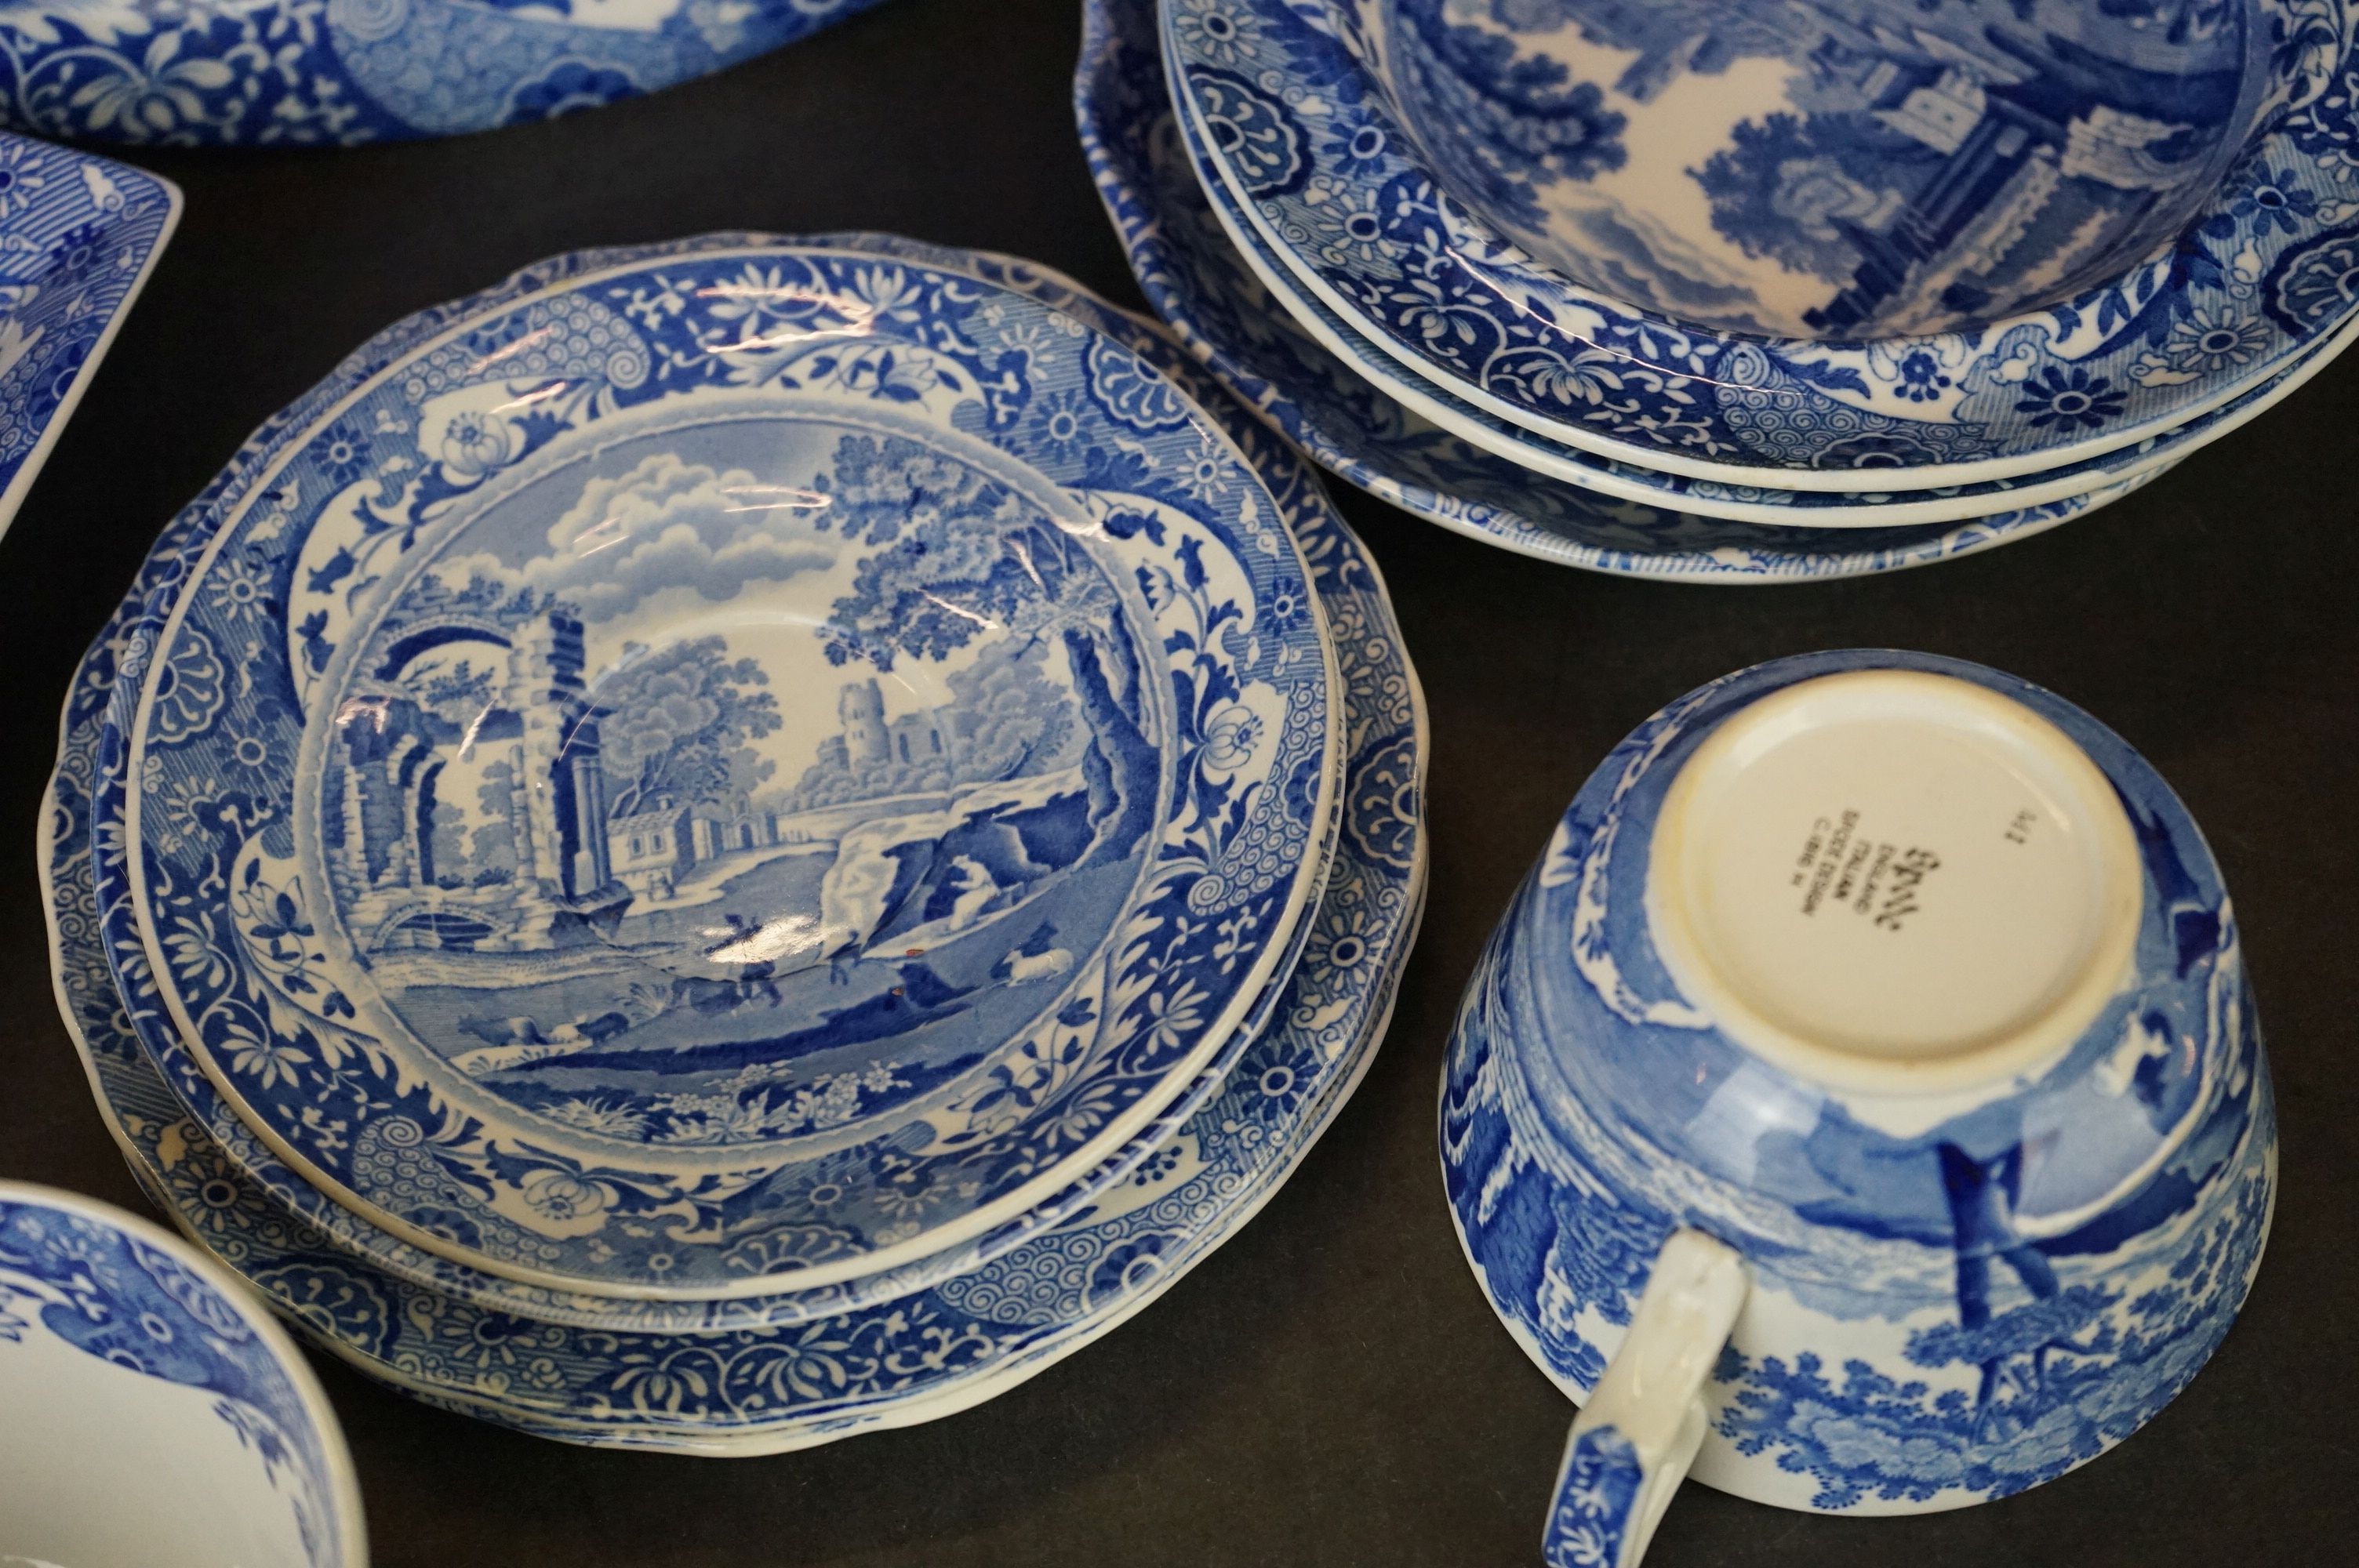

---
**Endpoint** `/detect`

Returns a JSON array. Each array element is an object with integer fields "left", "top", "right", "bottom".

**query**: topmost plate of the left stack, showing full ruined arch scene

[{"left": 127, "top": 245, "right": 1333, "bottom": 1299}]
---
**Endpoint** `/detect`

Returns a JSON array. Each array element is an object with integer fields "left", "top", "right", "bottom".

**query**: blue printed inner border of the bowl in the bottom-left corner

[{"left": 0, "top": 1196, "right": 361, "bottom": 1568}]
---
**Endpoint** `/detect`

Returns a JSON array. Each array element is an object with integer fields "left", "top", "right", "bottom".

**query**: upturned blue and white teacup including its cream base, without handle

[{"left": 1441, "top": 651, "right": 2277, "bottom": 1514}]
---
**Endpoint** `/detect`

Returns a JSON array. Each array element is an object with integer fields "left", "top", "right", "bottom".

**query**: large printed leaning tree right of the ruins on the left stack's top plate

[{"left": 819, "top": 436, "right": 1158, "bottom": 868}]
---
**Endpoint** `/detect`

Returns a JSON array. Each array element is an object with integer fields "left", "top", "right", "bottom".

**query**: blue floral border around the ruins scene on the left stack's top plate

[{"left": 118, "top": 241, "right": 1331, "bottom": 1294}]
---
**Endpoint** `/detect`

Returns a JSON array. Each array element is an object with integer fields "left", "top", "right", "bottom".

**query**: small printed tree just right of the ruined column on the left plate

[{"left": 599, "top": 637, "right": 781, "bottom": 816}]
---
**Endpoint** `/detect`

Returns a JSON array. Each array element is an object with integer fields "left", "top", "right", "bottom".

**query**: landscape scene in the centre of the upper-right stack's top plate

[{"left": 1359, "top": 0, "right": 2270, "bottom": 339}]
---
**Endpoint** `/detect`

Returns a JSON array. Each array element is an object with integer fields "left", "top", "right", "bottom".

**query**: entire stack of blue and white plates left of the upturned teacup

[{"left": 42, "top": 236, "right": 1427, "bottom": 1455}]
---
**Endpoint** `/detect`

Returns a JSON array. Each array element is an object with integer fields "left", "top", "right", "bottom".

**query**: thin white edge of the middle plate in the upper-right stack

[{"left": 1155, "top": 29, "right": 2352, "bottom": 531}]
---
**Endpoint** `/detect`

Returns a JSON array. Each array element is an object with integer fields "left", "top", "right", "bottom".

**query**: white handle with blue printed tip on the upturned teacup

[{"left": 1540, "top": 1231, "right": 1750, "bottom": 1568}]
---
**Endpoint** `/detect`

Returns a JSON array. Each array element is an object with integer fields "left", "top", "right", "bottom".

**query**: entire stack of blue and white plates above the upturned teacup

[{"left": 1076, "top": 0, "right": 2359, "bottom": 583}]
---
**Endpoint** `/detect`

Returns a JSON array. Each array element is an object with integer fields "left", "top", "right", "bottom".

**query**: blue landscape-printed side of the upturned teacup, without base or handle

[{"left": 1441, "top": 653, "right": 2277, "bottom": 1512}]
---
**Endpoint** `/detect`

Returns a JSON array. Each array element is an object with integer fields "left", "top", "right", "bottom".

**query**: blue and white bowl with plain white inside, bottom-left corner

[{"left": 0, "top": 1181, "right": 368, "bottom": 1568}]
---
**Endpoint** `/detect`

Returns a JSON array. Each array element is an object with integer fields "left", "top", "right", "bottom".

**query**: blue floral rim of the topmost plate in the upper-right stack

[{"left": 1163, "top": 0, "right": 2359, "bottom": 491}]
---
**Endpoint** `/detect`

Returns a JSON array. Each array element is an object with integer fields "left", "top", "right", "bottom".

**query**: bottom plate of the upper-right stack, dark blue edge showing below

[{"left": 1074, "top": 0, "right": 2170, "bottom": 585}]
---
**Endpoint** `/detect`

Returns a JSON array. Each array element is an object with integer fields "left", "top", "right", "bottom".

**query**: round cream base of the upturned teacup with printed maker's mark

[{"left": 1647, "top": 670, "right": 2142, "bottom": 1094}]
